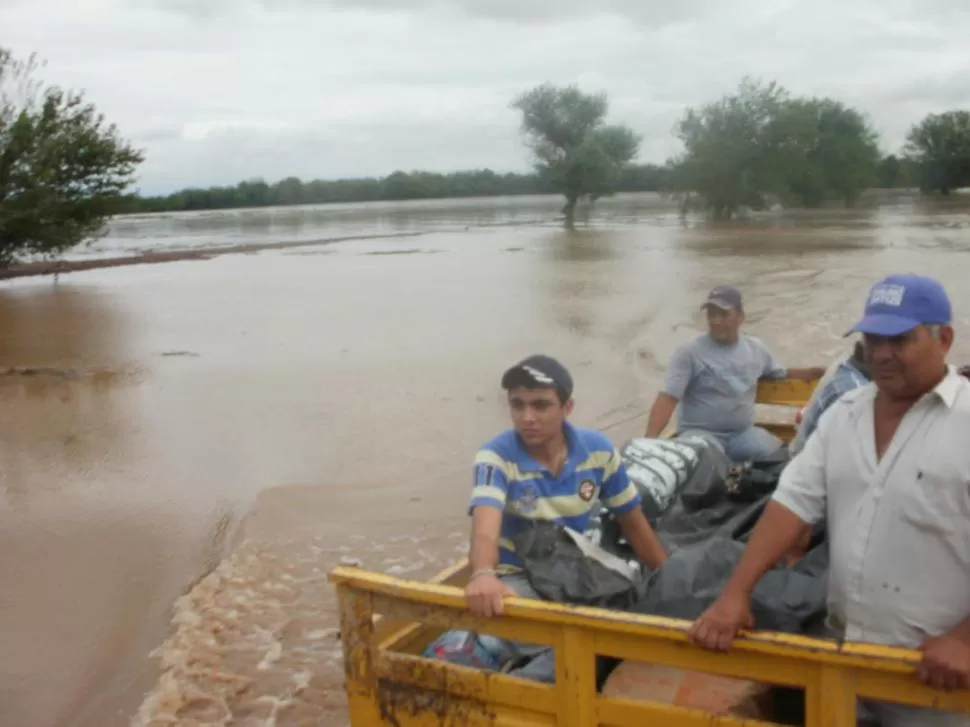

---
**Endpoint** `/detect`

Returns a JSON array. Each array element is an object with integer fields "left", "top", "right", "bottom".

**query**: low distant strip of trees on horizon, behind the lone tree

[{"left": 120, "top": 164, "right": 670, "bottom": 213}]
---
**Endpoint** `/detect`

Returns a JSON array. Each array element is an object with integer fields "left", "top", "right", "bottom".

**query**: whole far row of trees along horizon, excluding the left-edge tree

[{"left": 121, "top": 79, "right": 952, "bottom": 225}]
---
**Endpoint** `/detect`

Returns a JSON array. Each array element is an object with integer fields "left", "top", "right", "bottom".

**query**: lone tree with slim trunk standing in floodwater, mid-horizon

[{"left": 512, "top": 84, "right": 640, "bottom": 227}]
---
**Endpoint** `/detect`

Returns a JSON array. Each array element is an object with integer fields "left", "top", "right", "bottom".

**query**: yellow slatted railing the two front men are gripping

[{"left": 330, "top": 567, "right": 970, "bottom": 727}]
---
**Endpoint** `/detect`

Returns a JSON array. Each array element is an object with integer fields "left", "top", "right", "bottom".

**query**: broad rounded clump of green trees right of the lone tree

[{"left": 672, "top": 78, "right": 880, "bottom": 218}]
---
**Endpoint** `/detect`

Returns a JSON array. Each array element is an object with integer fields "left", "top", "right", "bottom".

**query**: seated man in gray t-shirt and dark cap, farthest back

[{"left": 646, "top": 285, "right": 825, "bottom": 462}]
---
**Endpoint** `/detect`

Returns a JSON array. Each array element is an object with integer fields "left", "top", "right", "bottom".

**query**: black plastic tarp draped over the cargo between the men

[{"left": 516, "top": 438, "right": 828, "bottom": 633}]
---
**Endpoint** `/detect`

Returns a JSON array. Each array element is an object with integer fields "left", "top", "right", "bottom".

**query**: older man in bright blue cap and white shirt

[{"left": 691, "top": 275, "right": 970, "bottom": 727}]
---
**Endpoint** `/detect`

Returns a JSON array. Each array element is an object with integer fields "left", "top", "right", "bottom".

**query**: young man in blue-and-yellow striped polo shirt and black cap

[{"left": 465, "top": 355, "right": 666, "bottom": 680}]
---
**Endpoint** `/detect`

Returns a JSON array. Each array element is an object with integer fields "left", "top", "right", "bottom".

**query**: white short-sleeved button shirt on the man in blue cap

[{"left": 774, "top": 367, "right": 970, "bottom": 648}]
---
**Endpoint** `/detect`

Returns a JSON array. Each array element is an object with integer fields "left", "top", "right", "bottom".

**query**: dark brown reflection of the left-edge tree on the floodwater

[{"left": 0, "top": 283, "right": 140, "bottom": 510}]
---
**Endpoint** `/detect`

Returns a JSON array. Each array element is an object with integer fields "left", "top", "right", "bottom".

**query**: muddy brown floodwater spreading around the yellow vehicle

[{"left": 0, "top": 196, "right": 970, "bottom": 727}]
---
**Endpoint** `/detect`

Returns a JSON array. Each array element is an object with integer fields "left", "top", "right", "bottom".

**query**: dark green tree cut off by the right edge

[{"left": 905, "top": 111, "right": 970, "bottom": 194}]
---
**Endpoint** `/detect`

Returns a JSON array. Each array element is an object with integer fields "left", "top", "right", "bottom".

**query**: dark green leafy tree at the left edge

[{"left": 0, "top": 48, "right": 142, "bottom": 266}]
